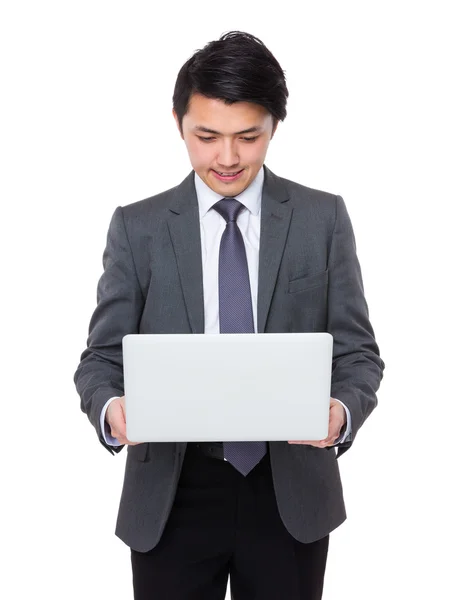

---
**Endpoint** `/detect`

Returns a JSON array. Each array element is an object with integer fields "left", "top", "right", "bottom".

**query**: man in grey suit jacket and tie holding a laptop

[{"left": 74, "top": 32, "right": 385, "bottom": 600}]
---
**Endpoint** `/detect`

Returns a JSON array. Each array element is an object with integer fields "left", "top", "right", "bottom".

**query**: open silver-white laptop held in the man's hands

[{"left": 122, "top": 332, "right": 333, "bottom": 442}]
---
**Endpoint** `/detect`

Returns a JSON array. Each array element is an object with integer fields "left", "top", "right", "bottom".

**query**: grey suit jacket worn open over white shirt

[{"left": 74, "top": 165, "right": 385, "bottom": 552}]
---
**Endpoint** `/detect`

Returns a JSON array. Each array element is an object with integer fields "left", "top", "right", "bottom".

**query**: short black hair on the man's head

[{"left": 173, "top": 31, "right": 288, "bottom": 133}]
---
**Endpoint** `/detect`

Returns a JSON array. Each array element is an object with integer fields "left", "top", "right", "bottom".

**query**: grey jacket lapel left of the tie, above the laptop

[{"left": 168, "top": 171, "right": 204, "bottom": 333}]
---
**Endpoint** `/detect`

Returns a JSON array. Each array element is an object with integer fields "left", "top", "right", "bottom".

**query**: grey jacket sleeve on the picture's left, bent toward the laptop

[{"left": 74, "top": 206, "right": 144, "bottom": 454}]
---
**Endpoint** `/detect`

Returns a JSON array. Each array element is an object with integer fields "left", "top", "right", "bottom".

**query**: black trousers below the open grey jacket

[{"left": 131, "top": 444, "right": 329, "bottom": 600}]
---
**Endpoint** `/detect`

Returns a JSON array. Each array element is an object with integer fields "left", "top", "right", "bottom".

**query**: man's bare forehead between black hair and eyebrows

[{"left": 184, "top": 94, "right": 272, "bottom": 133}]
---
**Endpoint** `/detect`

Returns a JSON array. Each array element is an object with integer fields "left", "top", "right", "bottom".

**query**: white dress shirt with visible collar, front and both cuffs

[{"left": 100, "top": 169, "right": 351, "bottom": 446}]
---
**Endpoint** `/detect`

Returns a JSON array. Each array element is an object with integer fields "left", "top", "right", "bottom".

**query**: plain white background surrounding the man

[{"left": 0, "top": 0, "right": 456, "bottom": 600}]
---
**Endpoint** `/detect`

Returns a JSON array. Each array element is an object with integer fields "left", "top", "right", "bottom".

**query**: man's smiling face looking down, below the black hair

[{"left": 173, "top": 94, "right": 277, "bottom": 196}]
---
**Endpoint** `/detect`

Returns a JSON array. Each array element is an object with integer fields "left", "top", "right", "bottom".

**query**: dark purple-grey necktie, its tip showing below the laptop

[{"left": 213, "top": 198, "right": 267, "bottom": 476}]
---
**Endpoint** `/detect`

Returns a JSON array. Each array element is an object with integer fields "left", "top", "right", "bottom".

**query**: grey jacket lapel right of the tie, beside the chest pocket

[{"left": 257, "top": 165, "right": 293, "bottom": 333}]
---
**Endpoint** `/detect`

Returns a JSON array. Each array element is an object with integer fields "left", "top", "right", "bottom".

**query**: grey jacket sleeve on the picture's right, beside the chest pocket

[{"left": 328, "top": 196, "right": 385, "bottom": 458}]
